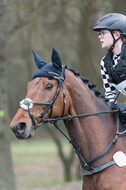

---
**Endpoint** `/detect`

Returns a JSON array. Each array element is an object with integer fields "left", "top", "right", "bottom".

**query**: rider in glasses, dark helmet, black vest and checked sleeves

[{"left": 93, "top": 13, "right": 126, "bottom": 116}]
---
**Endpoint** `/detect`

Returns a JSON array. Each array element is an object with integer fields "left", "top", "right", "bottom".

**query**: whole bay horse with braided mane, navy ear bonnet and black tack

[{"left": 10, "top": 49, "right": 126, "bottom": 190}]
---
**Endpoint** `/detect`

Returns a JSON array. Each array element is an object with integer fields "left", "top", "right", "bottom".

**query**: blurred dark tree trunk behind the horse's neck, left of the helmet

[{"left": 77, "top": 0, "right": 97, "bottom": 78}]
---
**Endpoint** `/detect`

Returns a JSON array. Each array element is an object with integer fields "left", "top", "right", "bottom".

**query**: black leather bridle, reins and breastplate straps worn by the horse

[{"left": 20, "top": 66, "right": 126, "bottom": 175}]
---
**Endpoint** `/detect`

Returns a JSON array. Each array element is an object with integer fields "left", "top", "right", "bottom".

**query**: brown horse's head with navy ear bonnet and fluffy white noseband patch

[{"left": 10, "top": 49, "right": 69, "bottom": 139}]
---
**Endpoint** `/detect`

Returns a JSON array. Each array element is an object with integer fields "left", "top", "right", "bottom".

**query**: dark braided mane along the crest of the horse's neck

[{"left": 67, "top": 68, "right": 108, "bottom": 102}]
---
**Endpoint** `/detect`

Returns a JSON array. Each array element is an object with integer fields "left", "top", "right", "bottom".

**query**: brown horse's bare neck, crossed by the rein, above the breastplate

[{"left": 64, "top": 71, "right": 115, "bottom": 160}]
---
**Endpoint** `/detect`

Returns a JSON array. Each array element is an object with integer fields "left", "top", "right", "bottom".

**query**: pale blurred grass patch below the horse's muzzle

[{"left": 11, "top": 140, "right": 77, "bottom": 190}]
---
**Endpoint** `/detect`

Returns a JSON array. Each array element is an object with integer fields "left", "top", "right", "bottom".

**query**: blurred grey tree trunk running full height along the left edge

[{"left": 0, "top": 0, "right": 15, "bottom": 190}]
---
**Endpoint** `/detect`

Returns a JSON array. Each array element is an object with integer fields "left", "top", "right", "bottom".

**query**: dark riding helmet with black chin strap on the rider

[{"left": 93, "top": 13, "right": 126, "bottom": 49}]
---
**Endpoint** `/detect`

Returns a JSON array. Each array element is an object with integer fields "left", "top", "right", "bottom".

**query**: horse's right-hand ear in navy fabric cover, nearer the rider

[{"left": 52, "top": 48, "right": 62, "bottom": 69}]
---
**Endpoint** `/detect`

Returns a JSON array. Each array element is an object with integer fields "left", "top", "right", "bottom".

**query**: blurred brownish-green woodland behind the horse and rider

[{"left": 0, "top": 0, "right": 126, "bottom": 190}]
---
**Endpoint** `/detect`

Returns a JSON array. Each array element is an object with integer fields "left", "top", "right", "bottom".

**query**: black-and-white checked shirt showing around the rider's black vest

[{"left": 101, "top": 54, "right": 126, "bottom": 102}]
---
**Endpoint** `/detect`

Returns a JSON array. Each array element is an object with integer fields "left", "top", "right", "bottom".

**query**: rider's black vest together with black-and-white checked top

[{"left": 101, "top": 44, "right": 126, "bottom": 102}]
